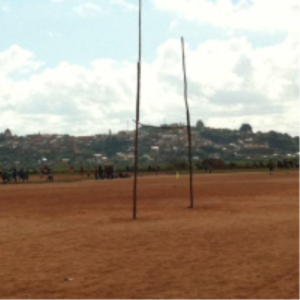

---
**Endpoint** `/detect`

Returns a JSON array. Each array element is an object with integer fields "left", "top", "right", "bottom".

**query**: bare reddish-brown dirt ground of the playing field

[{"left": 0, "top": 172, "right": 299, "bottom": 299}]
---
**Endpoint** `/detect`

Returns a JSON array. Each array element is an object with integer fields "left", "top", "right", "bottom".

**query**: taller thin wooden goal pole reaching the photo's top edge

[{"left": 132, "top": 0, "right": 142, "bottom": 219}]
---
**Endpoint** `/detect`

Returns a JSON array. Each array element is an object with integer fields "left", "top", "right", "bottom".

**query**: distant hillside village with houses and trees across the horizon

[{"left": 0, "top": 121, "right": 299, "bottom": 168}]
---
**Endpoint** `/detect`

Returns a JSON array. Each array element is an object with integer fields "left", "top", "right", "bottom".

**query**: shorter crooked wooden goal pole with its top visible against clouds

[{"left": 181, "top": 37, "right": 194, "bottom": 208}]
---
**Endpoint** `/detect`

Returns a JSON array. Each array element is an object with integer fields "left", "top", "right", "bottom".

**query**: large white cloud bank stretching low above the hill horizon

[{"left": 0, "top": 34, "right": 299, "bottom": 135}]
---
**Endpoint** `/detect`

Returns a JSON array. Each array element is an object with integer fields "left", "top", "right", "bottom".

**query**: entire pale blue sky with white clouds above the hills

[{"left": 0, "top": 0, "right": 299, "bottom": 136}]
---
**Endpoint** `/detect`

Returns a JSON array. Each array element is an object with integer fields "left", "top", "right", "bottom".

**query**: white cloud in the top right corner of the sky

[{"left": 152, "top": 0, "right": 299, "bottom": 32}]
